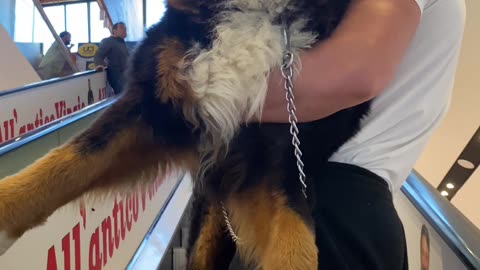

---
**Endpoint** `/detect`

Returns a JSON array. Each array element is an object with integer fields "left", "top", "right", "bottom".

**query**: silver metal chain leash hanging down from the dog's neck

[{"left": 220, "top": 18, "right": 307, "bottom": 243}]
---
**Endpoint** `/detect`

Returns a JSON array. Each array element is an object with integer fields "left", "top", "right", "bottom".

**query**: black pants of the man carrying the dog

[{"left": 313, "top": 163, "right": 408, "bottom": 270}]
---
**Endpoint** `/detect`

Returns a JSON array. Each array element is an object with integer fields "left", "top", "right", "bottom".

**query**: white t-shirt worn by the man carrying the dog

[{"left": 331, "top": 0, "right": 465, "bottom": 192}]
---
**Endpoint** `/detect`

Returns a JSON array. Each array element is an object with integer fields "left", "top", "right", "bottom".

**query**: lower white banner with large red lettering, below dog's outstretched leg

[{"left": 0, "top": 174, "right": 181, "bottom": 270}]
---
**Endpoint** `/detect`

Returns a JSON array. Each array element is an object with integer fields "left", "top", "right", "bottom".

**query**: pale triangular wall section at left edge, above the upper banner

[{"left": 0, "top": 25, "right": 40, "bottom": 91}]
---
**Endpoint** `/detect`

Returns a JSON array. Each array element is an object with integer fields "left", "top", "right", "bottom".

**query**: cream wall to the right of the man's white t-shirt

[{"left": 415, "top": 0, "right": 480, "bottom": 228}]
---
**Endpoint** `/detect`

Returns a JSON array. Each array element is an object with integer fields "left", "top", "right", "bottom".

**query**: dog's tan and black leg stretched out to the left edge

[{"left": 0, "top": 93, "right": 196, "bottom": 254}]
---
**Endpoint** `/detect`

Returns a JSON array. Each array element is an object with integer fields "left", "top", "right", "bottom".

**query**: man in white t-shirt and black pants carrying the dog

[{"left": 260, "top": 0, "right": 465, "bottom": 270}]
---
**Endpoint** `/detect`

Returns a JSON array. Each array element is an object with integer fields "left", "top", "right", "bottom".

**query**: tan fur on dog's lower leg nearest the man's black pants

[{"left": 227, "top": 186, "right": 318, "bottom": 270}]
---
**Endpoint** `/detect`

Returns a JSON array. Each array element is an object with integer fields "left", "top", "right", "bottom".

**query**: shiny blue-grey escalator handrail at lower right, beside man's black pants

[{"left": 402, "top": 171, "right": 480, "bottom": 269}]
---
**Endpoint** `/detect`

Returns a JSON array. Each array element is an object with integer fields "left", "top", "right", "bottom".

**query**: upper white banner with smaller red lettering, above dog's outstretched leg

[{"left": 0, "top": 72, "right": 110, "bottom": 144}]
